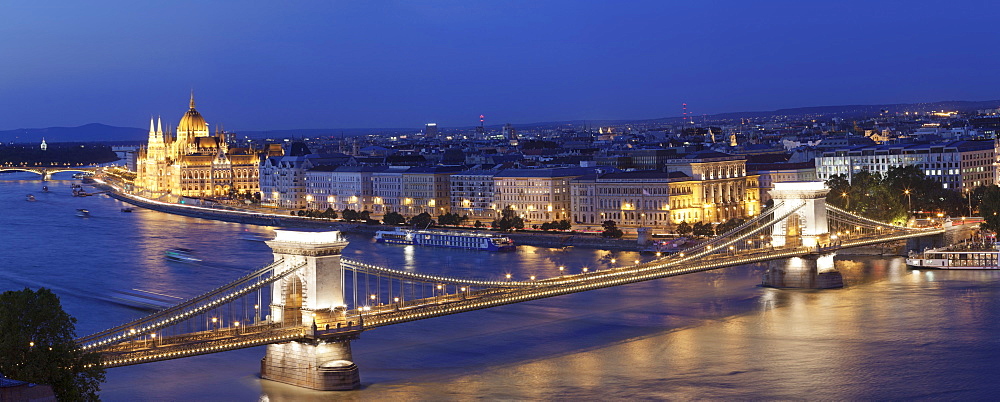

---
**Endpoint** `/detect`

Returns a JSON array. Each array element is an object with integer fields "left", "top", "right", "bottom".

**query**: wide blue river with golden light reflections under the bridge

[{"left": 0, "top": 173, "right": 1000, "bottom": 401}]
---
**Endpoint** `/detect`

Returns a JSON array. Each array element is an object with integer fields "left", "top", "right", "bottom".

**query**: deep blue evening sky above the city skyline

[{"left": 0, "top": 0, "right": 1000, "bottom": 130}]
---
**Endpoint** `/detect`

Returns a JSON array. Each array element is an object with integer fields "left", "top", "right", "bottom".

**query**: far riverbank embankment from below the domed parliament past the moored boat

[{"left": 93, "top": 183, "right": 642, "bottom": 251}]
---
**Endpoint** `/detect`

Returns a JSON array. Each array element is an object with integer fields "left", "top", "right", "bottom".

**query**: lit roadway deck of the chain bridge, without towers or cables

[{"left": 100, "top": 228, "right": 944, "bottom": 367}]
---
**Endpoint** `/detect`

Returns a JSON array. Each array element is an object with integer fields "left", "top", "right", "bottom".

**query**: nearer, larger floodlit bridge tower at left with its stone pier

[{"left": 261, "top": 230, "right": 360, "bottom": 391}]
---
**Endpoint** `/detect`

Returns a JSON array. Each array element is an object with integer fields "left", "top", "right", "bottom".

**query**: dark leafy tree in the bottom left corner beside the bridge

[{"left": 0, "top": 288, "right": 104, "bottom": 400}]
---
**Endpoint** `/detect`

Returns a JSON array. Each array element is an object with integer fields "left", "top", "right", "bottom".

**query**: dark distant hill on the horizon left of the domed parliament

[{"left": 0, "top": 123, "right": 149, "bottom": 143}]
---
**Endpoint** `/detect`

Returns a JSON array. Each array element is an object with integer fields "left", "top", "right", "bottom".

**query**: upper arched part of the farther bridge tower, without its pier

[{"left": 770, "top": 181, "right": 830, "bottom": 247}]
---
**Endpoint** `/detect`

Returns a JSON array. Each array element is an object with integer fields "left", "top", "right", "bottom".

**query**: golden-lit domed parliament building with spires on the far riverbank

[{"left": 135, "top": 93, "right": 260, "bottom": 197}]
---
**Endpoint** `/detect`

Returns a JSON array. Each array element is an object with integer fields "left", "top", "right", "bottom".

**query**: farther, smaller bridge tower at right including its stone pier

[{"left": 764, "top": 181, "right": 844, "bottom": 289}]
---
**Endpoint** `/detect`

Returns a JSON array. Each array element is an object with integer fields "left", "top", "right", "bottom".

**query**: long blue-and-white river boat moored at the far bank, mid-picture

[{"left": 375, "top": 228, "right": 514, "bottom": 251}]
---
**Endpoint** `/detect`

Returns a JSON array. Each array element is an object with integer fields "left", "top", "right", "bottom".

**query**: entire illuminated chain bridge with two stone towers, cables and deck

[{"left": 77, "top": 182, "right": 944, "bottom": 390}]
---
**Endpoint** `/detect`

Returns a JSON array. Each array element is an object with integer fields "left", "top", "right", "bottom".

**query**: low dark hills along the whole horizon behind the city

[{"left": 11, "top": 100, "right": 1000, "bottom": 143}]
